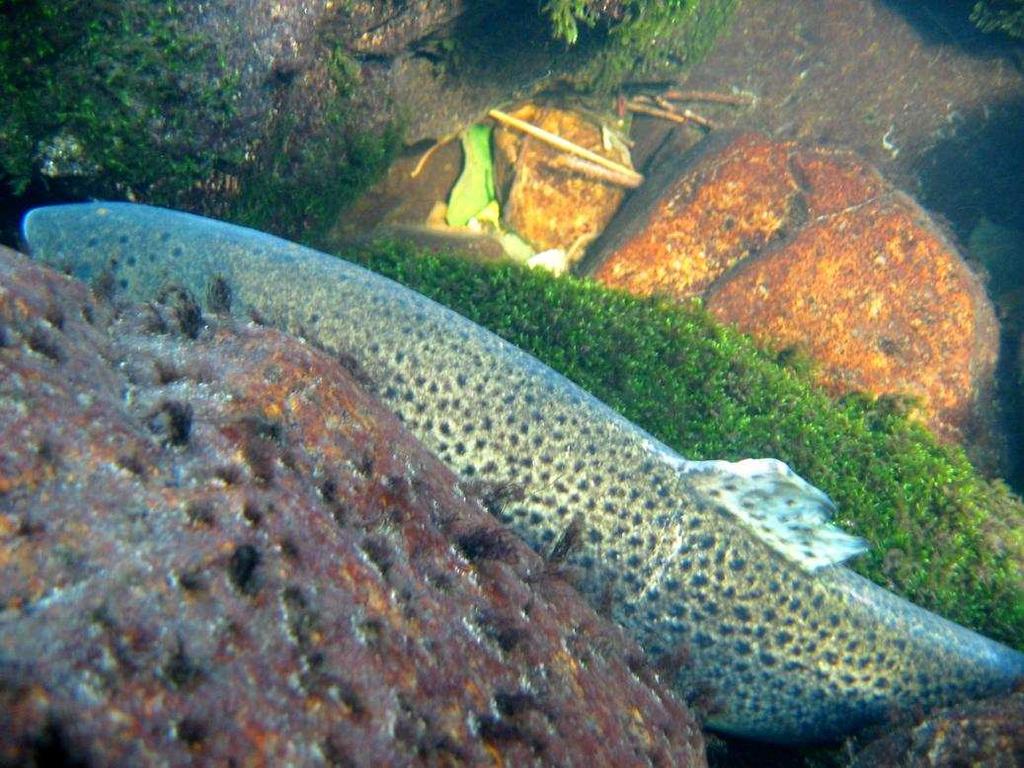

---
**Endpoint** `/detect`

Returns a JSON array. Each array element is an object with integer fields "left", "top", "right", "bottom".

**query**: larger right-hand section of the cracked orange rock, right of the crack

[{"left": 708, "top": 193, "right": 998, "bottom": 448}]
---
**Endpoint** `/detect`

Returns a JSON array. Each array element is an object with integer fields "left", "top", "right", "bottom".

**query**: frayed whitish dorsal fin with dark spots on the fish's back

[{"left": 681, "top": 459, "right": 867, "bottom": 571}]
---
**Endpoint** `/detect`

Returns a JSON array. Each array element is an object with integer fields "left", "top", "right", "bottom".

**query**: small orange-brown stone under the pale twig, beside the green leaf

[{"left": 495, "top": 104, "right": 632, "bottom": 265}]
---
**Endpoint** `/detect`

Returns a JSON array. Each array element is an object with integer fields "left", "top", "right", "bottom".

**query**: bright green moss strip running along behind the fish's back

[{"left": 345, "top": 243, "right": 1024, "bottom": 647}]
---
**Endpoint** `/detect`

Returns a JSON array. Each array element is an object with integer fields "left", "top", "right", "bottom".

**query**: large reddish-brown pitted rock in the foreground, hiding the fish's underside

[{"left": 0, "top": 251, "right": 705, "bottom": 765}]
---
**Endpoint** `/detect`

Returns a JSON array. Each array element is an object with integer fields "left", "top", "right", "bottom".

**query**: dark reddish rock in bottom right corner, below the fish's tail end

[{"left": 851, "top": 691, "right": 1024, "bottom": 768}]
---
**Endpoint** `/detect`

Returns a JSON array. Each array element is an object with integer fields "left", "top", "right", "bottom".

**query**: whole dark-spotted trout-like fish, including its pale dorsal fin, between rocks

[{"left": 23, "top": 204, "right": 1024, "bottom": 742}]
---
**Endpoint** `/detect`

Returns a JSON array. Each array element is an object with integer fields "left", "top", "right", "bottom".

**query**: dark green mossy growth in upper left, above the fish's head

[{"left": 0, "top": 0, "right": 401, "bottom": 238}]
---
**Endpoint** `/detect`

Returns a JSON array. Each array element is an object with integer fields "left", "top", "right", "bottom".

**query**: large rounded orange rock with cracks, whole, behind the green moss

[{"left": 596, "top": 133, "right": 998, "bottom": 444}]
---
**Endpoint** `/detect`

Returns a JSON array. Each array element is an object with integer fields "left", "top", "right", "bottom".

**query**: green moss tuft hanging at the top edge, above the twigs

[{"left": 543, "top": 0, "right": 737, "bottom": 90}]
